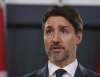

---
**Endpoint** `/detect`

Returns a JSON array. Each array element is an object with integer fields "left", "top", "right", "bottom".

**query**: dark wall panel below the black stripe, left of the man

[{"left": 8, "top": 29, "right": 46, "bottom": 77}]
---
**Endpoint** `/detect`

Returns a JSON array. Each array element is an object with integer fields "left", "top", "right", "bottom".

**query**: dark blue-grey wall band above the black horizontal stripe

[{"left": 7, "top": 5, "right": 100, "bottom": 26}]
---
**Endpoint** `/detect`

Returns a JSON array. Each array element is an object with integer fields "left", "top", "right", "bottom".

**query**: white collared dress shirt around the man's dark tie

[{"left": 48, "top": 59, "right": 78, "bottom": 77}]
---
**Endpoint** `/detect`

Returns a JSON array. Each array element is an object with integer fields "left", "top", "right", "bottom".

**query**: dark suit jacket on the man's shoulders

[{"left": 22, "top": 64, "right": 100, "bottom": 77}]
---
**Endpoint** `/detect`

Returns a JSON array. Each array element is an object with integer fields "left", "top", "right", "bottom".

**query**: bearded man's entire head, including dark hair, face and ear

[{"left": 42, "top": 6, "right": 83, "bottom": 66}]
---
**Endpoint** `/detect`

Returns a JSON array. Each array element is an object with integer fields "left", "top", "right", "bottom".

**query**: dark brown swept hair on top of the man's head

[{"left": 42, "top": 6, "right": 83, "bottom": 33}]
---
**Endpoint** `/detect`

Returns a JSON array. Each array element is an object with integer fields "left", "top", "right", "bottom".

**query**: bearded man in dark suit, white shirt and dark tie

[{"left": 23, "top": 6, "right": 100, "bottom": 77}]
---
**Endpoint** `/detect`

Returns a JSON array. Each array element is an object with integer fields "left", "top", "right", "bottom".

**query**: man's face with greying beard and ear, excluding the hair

[{"left": 44, "top": 16, "right": 82, "bottom": 62}]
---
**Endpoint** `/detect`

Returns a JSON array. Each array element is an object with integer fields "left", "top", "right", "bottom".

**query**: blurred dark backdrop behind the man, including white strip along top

[{"left": 0, "top": 0, "right": 100, "bottom": 77}]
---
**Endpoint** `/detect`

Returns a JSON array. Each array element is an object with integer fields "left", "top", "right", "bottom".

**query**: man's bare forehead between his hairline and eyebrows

[{"left": 45, "top": 16, "right": 72, "bottom": 28}]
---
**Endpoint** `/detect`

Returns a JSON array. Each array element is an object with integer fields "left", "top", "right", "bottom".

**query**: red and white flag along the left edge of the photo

[{"left": 0, "top": 2, "right": 7, "bottom": 77}]
